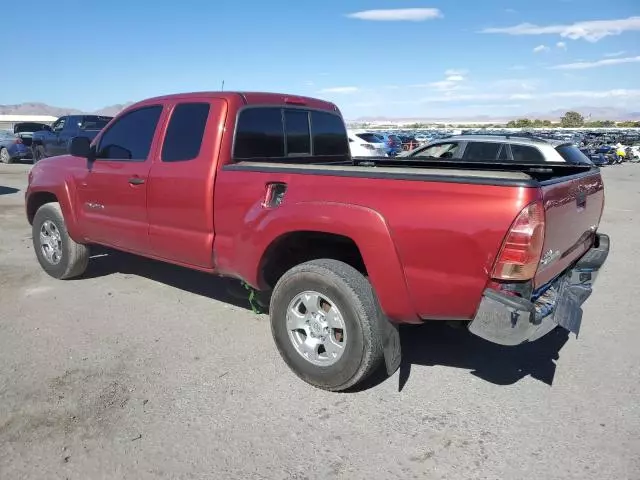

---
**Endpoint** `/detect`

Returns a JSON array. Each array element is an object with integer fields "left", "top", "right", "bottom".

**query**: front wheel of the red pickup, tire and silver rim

[{"left": 32, "top": 202, "right": 89, "bottom": 280}]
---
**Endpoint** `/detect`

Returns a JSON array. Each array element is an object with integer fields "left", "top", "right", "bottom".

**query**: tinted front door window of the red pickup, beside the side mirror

[{"left": 96, "top": 105, "right": 162, "bottom": 162}]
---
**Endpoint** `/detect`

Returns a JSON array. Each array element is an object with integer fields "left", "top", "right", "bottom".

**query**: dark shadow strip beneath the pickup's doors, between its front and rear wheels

[{"left": 83, "top": 247, "right": 258, "bottom": 310}]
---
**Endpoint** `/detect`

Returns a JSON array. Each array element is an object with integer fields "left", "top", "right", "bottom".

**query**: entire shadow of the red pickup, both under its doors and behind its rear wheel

[{"left": 84, "top": 247, "right": 569, "bottom": 391}]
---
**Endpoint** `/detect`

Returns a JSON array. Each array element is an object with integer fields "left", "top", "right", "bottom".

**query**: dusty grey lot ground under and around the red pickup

[{"left": 0, "top": 165, "right": 640, "bottom": 480}]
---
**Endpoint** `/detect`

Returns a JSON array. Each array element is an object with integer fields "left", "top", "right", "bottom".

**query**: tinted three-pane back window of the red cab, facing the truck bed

[{"left": 233, "top": 107, "right": 350, "bottom": 163}]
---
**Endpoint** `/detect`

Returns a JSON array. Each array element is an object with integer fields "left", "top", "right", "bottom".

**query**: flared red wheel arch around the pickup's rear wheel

[{"left": 249, "top": 202, "right": 420, "bottom": 323}]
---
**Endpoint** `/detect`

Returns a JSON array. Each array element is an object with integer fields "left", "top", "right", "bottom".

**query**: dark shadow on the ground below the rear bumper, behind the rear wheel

[{"left": 359, "top": 322, "right": 569, "bottom": 391}]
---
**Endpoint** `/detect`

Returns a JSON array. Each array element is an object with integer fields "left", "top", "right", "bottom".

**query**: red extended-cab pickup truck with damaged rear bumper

[{"left": 26, "top": 92, "right": 609, "bottom": 391}]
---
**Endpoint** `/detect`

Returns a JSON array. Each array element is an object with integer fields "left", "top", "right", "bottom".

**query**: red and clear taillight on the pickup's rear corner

[{"left": 491, "top": 201, "right": 544, "bottom": 280}]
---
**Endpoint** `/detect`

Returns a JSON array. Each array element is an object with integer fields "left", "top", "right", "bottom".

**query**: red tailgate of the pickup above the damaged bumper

[{"left": 535, "top": 170, "right": 604, "bottom": 287}]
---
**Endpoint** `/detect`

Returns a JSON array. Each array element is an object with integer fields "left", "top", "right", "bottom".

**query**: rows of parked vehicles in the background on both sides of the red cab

[{"left": 0, "top": 115, "right": 640, "bottom": 165}]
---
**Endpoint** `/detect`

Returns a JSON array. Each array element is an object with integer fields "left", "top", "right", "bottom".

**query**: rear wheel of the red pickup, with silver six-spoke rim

[{"left": 269, "top": 259, "right": 386, "bottom": 392}]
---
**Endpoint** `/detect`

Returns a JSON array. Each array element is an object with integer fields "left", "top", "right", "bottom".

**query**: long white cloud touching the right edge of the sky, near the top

[{"left": 480, "top": 17, "right": 640, "bottom": 42}]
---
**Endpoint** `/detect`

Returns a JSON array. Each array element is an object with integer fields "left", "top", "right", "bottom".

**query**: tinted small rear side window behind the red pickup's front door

[{"left": 161, "top": 102, "right": 210, "bottom": 162}]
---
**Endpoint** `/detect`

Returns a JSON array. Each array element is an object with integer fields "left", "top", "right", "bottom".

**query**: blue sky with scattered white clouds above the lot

[{"left": 0, "top": 0, "right": 640, "bottom": 119}]
